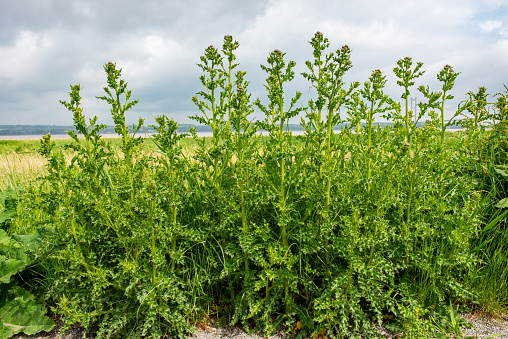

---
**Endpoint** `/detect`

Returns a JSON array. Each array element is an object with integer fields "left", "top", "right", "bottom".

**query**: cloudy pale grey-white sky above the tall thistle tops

[{"left": 0, "top": 0, "right": 508, "bottom": 125}]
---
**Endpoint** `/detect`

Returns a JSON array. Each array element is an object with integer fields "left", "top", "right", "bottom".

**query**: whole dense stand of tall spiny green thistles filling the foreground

[{"left": 0, "top": 32, "right": 508, "bottom": 338}]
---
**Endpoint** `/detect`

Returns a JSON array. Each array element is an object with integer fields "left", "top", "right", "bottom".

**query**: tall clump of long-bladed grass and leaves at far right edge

[{"left": 463, "top": 86, "right": 508, "bottom": 314}]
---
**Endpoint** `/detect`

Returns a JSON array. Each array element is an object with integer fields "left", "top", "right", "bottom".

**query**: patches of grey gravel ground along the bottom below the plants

[{"left": 12, "top": 314, "right": 508, "bottom": 339}]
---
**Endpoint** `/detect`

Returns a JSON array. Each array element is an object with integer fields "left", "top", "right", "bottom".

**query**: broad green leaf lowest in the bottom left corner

[{"left": 0, "top": 285, "right": 55, "bottom": 339}]
